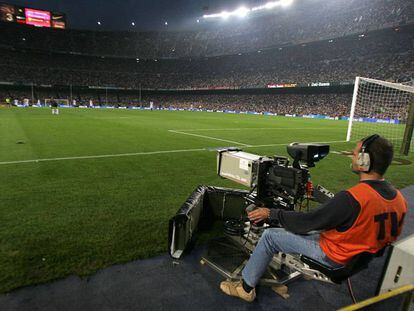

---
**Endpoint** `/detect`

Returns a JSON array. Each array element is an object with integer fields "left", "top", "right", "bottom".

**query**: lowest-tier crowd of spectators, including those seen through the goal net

[{"left": 4, "top": 90, "right": 410, "bottom": 120}]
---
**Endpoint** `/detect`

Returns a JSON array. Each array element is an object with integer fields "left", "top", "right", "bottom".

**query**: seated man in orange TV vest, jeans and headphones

[{"left": 220, "top": 135, "right": 407, "bottom": 302}]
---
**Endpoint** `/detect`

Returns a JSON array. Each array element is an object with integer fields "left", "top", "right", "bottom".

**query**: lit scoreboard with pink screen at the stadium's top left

[{"left": 0, "top": 3, "right": 66, "bottom": 29}]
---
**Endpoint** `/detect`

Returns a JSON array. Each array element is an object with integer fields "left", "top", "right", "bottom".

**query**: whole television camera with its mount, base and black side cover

[{"left": 169, "top": 143, "right": 356, "bottom": 286}]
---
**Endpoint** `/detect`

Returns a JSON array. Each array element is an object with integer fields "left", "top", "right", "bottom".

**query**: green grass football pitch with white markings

[{"left": 0, "top": 108, "right": 414, "bottom": 292}]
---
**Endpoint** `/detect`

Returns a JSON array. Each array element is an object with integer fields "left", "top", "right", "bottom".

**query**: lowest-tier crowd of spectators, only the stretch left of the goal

[{"left": 0, "top": 91, "right": 352, "bottom": 117}]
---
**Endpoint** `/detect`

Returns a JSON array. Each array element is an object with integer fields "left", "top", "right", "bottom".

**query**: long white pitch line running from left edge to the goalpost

[{"left": 0, "top": 140, "right": 347, "bottom": 165}]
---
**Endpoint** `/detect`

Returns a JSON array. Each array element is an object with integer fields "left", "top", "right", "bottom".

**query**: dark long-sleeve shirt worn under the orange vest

[{"left": 269, "top": 180, "right": 397, "bottom": 234}]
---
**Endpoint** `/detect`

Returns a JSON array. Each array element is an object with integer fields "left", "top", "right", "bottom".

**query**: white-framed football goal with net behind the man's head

[{"left": 346, "top": 77, "right": 414, "bottom": 155}]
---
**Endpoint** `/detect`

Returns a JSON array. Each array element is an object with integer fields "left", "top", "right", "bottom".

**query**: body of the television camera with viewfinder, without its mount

[{"left": 217, "top": 143, "right": 329, "bottom": 210}]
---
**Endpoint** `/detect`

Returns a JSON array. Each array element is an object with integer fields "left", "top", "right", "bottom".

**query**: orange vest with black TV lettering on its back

[{"left": 319, "top": 183, "right": 407, "bottom": 264}]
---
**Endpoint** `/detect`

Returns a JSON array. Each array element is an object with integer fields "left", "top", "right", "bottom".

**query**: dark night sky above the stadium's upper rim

[{"left": 1, "top": 0, "right": 267, "bottom": 30}]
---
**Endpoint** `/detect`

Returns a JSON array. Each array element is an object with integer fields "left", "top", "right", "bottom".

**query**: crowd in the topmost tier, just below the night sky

[{"left": 0, "top": 0, "right": 414, "bottom": 59}]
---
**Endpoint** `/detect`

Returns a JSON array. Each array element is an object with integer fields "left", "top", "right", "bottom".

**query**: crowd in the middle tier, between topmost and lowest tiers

[{"left": 0, "top": 25, "right": 414, "bottom": 89}]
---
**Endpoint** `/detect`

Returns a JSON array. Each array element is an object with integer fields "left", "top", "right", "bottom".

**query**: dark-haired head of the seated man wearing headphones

[{"left": 352, "top": 135, "right": 394, "bottom": 176}]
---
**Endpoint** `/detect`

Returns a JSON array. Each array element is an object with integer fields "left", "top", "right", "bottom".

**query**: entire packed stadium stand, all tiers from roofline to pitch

[{"left": 0, "top": 0, "right": 414, "bottom": 116}]
